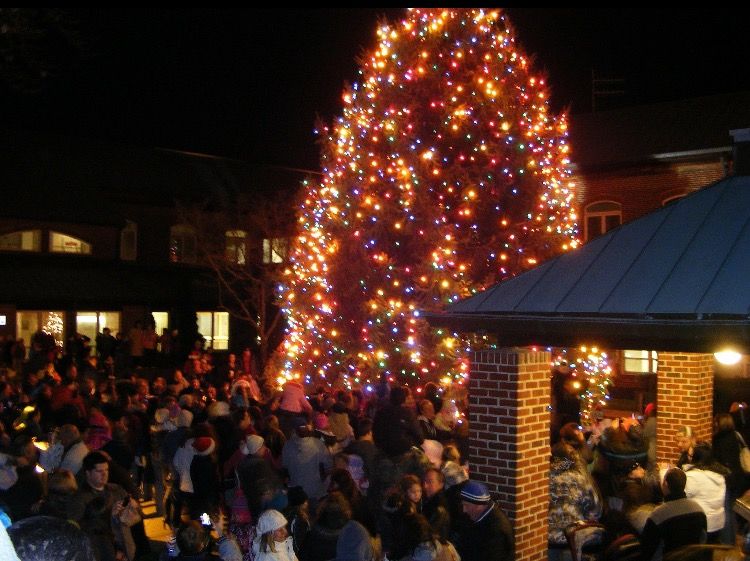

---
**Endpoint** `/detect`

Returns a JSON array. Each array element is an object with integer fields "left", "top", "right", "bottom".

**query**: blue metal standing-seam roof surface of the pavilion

[{"left": 446, "top": 176, "right": 750, "bottom": 319}]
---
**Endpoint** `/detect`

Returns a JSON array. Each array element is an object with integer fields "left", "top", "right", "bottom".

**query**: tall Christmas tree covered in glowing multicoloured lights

[{"left": 279, "top": 9, "right": 577, "bottom": 385}]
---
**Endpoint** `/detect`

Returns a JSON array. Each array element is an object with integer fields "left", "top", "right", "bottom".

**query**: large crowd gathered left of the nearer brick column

[{"left": 0, "top": 326, "right": 514, "bottom": 561}]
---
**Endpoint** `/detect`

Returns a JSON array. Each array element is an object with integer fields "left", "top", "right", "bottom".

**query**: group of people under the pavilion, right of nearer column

[{"left": 548, "top": 404, "right": 750, "bottom": 561}]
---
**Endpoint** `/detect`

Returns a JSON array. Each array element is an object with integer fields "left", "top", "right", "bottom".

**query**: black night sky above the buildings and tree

[{"left": 0, "top": 8, "right": 750, "bottom": 169}]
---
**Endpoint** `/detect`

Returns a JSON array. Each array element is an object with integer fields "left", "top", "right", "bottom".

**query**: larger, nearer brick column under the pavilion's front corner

[{"left": 469, "top": 348, "right": 550, "bottom": 561}]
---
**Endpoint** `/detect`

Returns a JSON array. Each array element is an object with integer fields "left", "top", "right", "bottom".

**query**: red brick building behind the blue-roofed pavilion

[{"left": 570, "top": 92, "right": 750, "bottom": 412}]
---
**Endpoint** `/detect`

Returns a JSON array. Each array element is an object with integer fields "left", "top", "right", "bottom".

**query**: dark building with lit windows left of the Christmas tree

[{"left": 0, "top": 132, "right": 299, "bottom": 360}]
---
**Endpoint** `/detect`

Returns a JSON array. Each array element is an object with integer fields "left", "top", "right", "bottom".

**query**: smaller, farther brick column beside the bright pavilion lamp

[{"left": 656, "top": 351, "right": 714, "bottom": 463}]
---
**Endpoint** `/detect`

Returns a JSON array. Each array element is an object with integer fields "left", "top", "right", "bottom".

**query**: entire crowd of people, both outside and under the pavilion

[{"left": 0, "top": 326, "right": 750, "bottom": 561}]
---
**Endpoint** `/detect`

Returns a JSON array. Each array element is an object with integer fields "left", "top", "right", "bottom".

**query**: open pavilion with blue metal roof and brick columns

[{"left": 428, "top": 123, "right": 750, "bottom": 561}]
